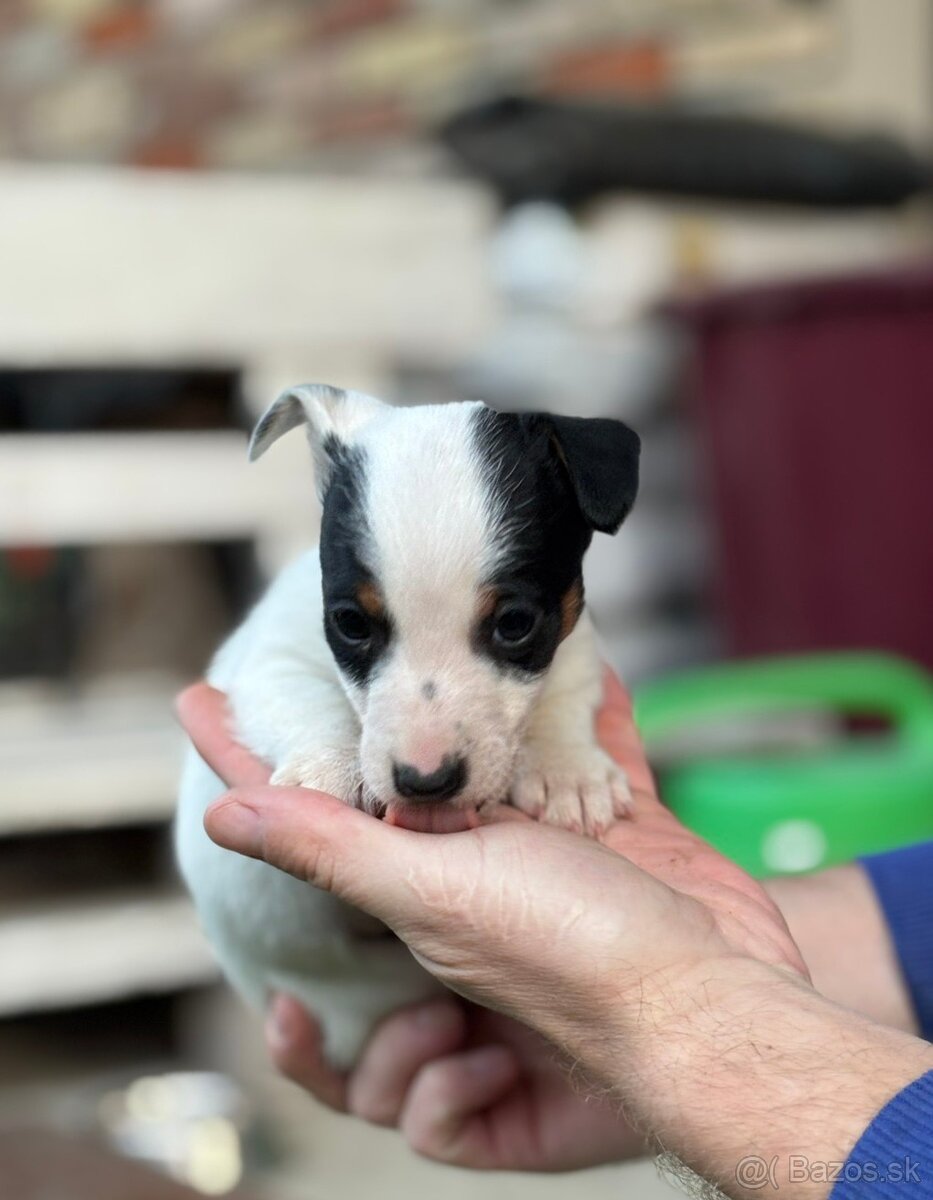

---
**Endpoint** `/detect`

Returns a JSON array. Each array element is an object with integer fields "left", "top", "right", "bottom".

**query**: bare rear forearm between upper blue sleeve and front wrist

[{"left": 765, "top": 864, "right": 917, "bottom": 1033}]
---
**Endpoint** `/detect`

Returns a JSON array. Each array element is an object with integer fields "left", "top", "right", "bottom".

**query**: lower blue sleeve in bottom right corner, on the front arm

[{"left": 830, "top": 1070, "right": 933, "bottom": 1200}]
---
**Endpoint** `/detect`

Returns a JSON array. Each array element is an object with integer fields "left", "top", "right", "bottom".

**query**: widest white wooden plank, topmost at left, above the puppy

[{"left": 0, "top": 164, "right": 493, "bottom": 367}]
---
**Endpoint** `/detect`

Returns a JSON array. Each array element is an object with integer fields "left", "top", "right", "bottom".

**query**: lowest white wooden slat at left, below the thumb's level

[{"left": 0, "top": 892, "right": 218, "bottom": 1016}]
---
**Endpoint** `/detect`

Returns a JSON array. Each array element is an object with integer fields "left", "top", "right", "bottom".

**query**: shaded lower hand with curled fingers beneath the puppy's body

[{"left": 266, "top": 996, "right": 645, "bottom": 1171}]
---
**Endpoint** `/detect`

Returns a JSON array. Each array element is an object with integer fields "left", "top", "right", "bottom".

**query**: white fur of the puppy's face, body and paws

[{"left": 176, "top": 394, "right": 628, "bottom": 1066}]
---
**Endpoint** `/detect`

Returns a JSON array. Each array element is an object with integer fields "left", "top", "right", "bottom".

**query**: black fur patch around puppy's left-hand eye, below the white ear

[{"left": 320, "top": 438, "right": 392, "bottom": 686}]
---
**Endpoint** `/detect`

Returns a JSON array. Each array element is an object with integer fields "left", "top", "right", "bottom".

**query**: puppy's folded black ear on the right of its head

[{"left": 534, "top": 416, "right": 642, "bottom": 533}]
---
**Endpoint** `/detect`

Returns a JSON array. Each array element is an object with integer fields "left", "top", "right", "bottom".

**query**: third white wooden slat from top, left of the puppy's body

[{"left": 0, "top": 678, "right": 183, "bottom": 836}]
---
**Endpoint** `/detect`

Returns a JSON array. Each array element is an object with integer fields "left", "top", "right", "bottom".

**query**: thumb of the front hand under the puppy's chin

[{"left": 204, "top": 786, "right": 426, "bottom": 925}]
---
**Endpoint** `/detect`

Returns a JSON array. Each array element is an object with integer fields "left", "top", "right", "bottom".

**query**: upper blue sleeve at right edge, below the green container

[{"left": 862, "top": 842, "right": 933, "bottom": 1042}]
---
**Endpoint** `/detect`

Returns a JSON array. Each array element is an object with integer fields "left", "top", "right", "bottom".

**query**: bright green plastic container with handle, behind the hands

[{"left": 636, "top": 654, "right": 933, "bottom": 876}]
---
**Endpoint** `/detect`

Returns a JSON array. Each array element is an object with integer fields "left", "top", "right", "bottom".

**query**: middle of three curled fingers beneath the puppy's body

[{"left": 347, "top": 1000, "right": 467, "bottom": 1127}]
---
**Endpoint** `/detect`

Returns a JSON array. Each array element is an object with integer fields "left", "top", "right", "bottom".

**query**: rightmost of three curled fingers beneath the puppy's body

[{"left": 399, "top": 1045, "right": 520, "bottom": 1169}]
